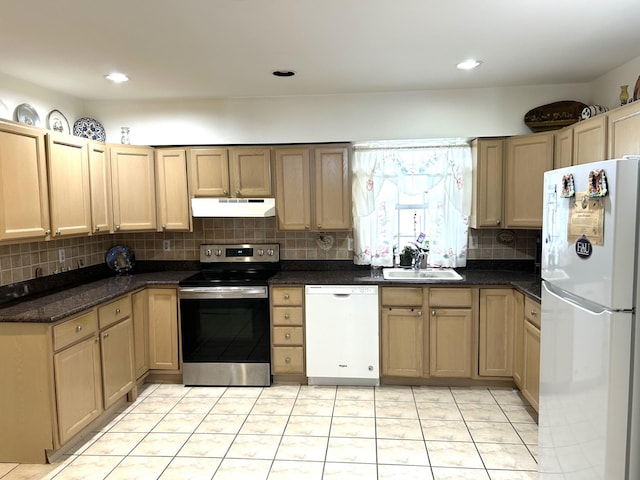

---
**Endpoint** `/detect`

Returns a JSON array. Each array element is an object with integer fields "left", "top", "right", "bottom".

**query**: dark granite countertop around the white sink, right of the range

[{"left": 269, "top": 268, "right": 540, "bottom": 301}]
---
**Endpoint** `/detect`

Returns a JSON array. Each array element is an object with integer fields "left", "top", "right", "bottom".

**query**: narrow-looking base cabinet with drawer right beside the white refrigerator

[{"left": 521, "top": 297, "right": 540, "bottom": 412}]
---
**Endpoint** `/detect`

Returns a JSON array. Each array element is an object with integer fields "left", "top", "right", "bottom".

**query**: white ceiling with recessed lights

[{"left": 0, "top": 0, "right": 640, "bottom": 99}]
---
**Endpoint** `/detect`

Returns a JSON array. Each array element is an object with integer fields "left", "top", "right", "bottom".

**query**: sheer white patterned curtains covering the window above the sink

[{"left": 353, "top": 143, "right": 471, "bottom": 267}]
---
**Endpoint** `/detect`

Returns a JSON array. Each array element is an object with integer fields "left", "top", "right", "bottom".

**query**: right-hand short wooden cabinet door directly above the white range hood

[{"left": 230, "top": 148, "right": 273, "bottom": 197}]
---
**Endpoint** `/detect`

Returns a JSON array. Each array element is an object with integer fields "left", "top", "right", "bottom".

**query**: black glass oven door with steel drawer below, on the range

[{"left": 180, "top": 286, "right": 271, "bottom": 386}]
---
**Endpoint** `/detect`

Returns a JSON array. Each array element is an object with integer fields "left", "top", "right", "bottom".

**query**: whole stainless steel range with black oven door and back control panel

[{"left": 180, "top": 243, "right": 280, "bottom": 386}]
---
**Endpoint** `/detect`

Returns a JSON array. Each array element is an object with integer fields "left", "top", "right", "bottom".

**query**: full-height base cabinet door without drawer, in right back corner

[{"left": 478, "top": 288, "right": 514, "bottom": 377}]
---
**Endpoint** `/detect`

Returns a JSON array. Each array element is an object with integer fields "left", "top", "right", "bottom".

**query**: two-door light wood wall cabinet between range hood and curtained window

[{"left": 274, "top": 145, "right": 351, "bottom": 231}]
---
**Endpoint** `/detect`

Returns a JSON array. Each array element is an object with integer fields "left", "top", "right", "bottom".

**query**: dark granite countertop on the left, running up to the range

[{"left": 0, "top": 271, "right": 193, "bottom": 323}]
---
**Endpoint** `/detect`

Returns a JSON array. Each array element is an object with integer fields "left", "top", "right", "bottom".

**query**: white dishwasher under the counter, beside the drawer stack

[{"left": 305, "top": 285, "right": 380, "bottom": 386}]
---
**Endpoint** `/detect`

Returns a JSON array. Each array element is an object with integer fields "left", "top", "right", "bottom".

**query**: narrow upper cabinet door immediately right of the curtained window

[{"left": 469, "top": 138, "right": 504, "bottom": 228}]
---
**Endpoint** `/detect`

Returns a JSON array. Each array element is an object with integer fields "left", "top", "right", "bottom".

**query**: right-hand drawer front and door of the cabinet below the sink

[{"left": 428, "top": 287, "right": 477, "bottom": 378}]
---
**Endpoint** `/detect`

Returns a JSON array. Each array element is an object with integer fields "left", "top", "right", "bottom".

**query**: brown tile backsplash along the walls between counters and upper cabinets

[{"left": 0, "top": 217, "right": 539, "bottom": 285}]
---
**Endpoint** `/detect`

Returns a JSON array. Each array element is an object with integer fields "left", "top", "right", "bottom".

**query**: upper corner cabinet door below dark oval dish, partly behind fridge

[{"left": 504, "top": 133, "right": 554, "bottom": 229}]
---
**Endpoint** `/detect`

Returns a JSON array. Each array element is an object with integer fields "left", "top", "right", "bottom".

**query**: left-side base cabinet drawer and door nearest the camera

[{"left": 53, "top": 309, "right": 104, "bottom": 445}]
